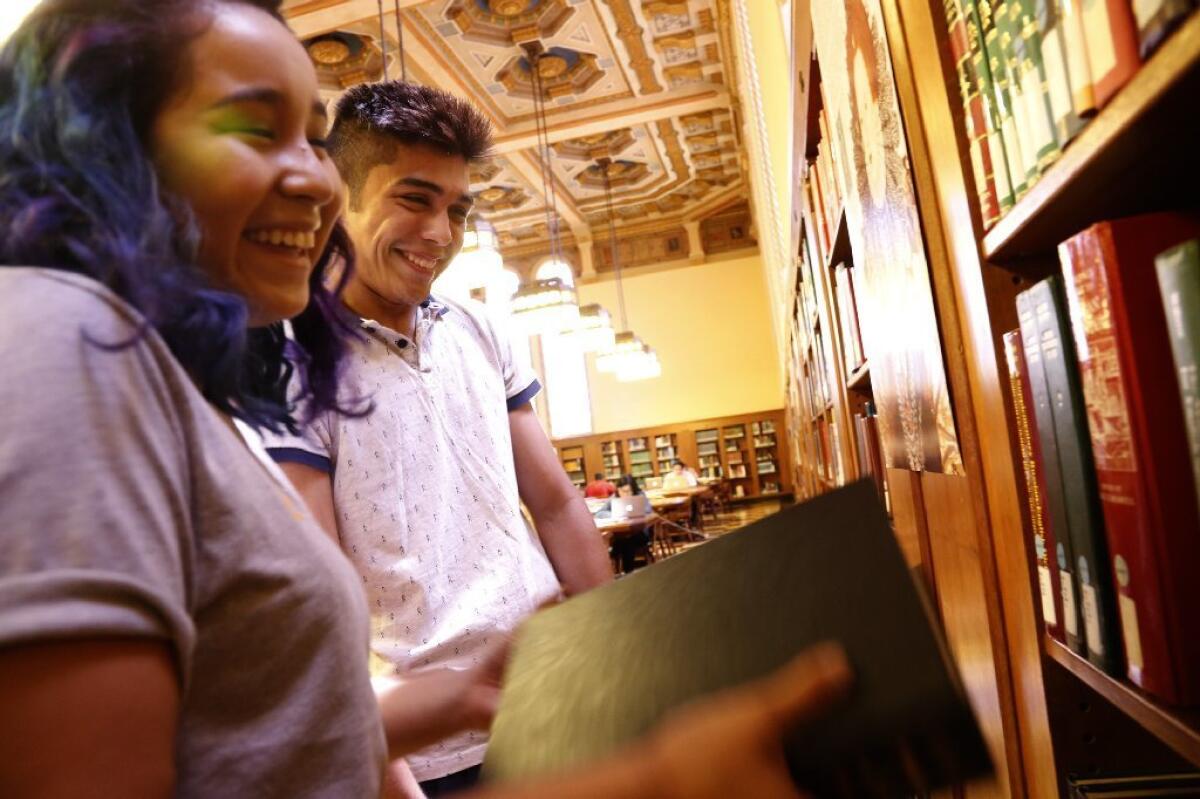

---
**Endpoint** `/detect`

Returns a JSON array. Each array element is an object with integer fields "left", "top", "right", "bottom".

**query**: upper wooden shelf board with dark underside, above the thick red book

[{"left": 983, "top": 12, "right": 1200, "bottom": 262}]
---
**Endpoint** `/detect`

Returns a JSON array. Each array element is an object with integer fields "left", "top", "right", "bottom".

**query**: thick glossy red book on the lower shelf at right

[{"left": 1060, "top": 214, "right": 1200, "bottom": 704}]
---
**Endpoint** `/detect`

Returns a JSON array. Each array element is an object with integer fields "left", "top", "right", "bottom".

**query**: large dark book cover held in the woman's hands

[{"left": 484, "top": 480, "right": 991, "bottom": 797}]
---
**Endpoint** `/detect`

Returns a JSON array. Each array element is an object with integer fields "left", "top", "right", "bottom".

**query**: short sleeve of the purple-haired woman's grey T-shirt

[{"left": 0, "top": 269, "right": 196, "bottom": 686}]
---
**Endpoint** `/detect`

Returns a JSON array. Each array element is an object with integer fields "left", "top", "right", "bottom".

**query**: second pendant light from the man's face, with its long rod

[{"left": 512, "top": 41, "right": 580, "bottom": 335}]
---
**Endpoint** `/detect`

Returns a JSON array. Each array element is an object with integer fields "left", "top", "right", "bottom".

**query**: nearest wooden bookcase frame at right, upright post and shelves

[{"left": 882, "top": 0, "right": 1200, "bottom": 799}]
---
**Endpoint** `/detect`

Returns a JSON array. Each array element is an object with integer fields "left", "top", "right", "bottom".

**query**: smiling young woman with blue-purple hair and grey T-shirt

[{"left": 0, "top": 0, "right": 846, "bottom": 798}]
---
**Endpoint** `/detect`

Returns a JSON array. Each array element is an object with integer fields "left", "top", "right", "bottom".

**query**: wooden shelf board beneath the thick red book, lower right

[{"left": 1043, "top": 636, "right": 1200, "bottom": 767}]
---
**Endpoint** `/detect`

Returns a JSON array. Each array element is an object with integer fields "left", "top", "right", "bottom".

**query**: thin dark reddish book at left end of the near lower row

[{"left": 1004, "top": 330, "right": 1067, "bottom": 643}]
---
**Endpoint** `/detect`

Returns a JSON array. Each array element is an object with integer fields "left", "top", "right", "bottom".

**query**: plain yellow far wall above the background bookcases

[{"left": 578, "top": 253, "right": 782, "bottom": 433}]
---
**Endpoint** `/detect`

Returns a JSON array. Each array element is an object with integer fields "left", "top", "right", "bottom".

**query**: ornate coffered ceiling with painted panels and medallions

[{"left": 283, "top": 0, "right": 751, "bottom": 272}]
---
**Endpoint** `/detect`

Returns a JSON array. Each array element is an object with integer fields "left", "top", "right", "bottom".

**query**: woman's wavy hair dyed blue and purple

[{"left": 0, "top": 0, "right": 354, "bottom": 431}]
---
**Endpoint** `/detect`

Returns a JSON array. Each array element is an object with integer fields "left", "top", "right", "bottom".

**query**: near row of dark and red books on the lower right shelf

[{"left": 1004, "top": 214, "right": 1200, "bottom": 705}]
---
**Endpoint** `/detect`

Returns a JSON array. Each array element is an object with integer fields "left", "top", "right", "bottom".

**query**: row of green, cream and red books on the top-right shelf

[{"left": 943, "top": 0, "right": 1195, "bottom": 228}]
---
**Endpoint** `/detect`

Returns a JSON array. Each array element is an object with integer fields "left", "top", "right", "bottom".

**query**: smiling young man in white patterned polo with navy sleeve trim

[{"left": 269, "top": 82, "right": 612, "bottom": 797}]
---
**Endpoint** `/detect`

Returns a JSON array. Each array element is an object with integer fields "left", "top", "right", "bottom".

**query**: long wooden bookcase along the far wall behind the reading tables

[{"left": 554, "top": 409, "right": 793, "bottom": 500}]
